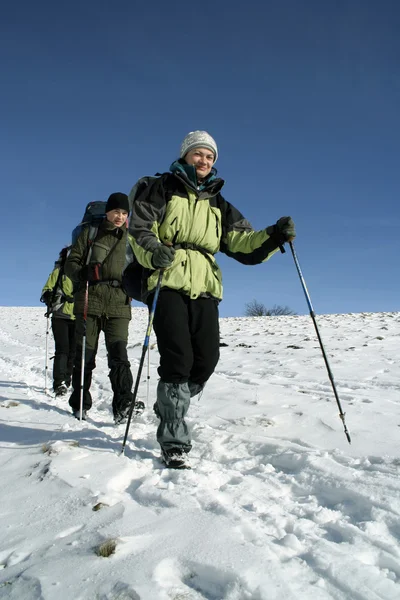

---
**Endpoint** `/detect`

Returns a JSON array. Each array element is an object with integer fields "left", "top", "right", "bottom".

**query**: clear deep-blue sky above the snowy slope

[{"left": 0, "top": 0, "right": 400, "bottom": 316}]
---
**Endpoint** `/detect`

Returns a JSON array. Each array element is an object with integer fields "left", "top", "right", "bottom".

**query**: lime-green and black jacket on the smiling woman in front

[{"left": 129, "top": 162, "right": 279, "bottom": 300}]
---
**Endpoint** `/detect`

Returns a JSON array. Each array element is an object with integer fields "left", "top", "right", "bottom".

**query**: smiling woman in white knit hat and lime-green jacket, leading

[{"left": 129, "top": 131, "right": 296, "bottom": 468}]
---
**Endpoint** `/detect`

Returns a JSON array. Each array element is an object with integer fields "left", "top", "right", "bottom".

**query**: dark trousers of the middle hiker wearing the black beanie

[{"left": 69, "top": 315, "right": 133, "bottom": 415}]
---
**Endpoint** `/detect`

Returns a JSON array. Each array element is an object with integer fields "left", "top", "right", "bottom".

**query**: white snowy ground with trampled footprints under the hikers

[{"left": 0, "top": 308, "right": 400, "bottom": 600}]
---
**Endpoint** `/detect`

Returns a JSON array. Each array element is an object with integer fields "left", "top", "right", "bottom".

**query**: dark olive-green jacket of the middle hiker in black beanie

[{"left": 65, "top": 219, "right": 131, "bottom": 319}]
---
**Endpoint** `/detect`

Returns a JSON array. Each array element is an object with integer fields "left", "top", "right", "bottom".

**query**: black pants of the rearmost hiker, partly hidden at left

[{"left": 51, "top": 316, "right": 75, "bottom": 390}]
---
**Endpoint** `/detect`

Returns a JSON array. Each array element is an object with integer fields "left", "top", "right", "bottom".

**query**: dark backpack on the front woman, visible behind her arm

[{"left": 122, "top": 173, "right": 165, "bottom": 304}]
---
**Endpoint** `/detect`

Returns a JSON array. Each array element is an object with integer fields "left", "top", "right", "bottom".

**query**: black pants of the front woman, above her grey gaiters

[{"left": 150, "top": 289, "right": 219, "bottom": 386}]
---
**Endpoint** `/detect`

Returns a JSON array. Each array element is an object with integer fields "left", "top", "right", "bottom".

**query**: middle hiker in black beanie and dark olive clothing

[{"left": 65, "top": 192, "right": 144, "bottom": 424}]
